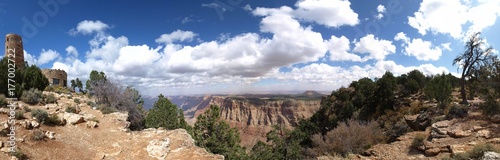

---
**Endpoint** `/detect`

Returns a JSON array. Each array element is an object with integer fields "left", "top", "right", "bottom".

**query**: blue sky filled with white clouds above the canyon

[{"left": 0, "top": 0, "right": 500, "bottom": 96}]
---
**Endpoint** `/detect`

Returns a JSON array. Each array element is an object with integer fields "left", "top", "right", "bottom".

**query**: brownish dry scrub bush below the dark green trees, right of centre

[{"left": 313, "top": 119, "right": 383, "bottom": 156}]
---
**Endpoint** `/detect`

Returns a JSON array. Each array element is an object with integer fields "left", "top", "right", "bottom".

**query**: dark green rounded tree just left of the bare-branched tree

[{"left": 425, "top": 73, "right": 453, "bottom": 106}]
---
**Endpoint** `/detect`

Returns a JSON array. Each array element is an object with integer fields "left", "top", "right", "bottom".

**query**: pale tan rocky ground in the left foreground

[{"left": 0, "top": 92, "right": 224, "bottom": 160}]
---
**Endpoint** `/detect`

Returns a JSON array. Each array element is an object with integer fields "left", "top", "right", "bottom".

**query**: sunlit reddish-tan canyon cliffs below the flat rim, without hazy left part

[{"left": 190, "top": 96, "right": 321, "bottom": 148}]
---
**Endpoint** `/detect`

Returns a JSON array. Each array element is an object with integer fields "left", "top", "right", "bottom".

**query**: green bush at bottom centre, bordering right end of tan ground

[{"left": 193, "top": 105, "right": 247, "bottom": 159}]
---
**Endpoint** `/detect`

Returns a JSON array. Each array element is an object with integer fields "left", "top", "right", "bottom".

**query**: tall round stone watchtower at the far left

[{"left": 5, "top": 34, "right": 24, "bottom": 68}]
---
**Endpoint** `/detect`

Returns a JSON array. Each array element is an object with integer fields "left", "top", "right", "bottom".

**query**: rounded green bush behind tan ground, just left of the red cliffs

[{"left": 145, "top": 94, "right": 187, "bottom": 130}]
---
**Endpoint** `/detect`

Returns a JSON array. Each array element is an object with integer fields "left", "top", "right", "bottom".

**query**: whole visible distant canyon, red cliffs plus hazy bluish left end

[{"left": 144, "top": 91, "right": 326, "bottom": 149}]
